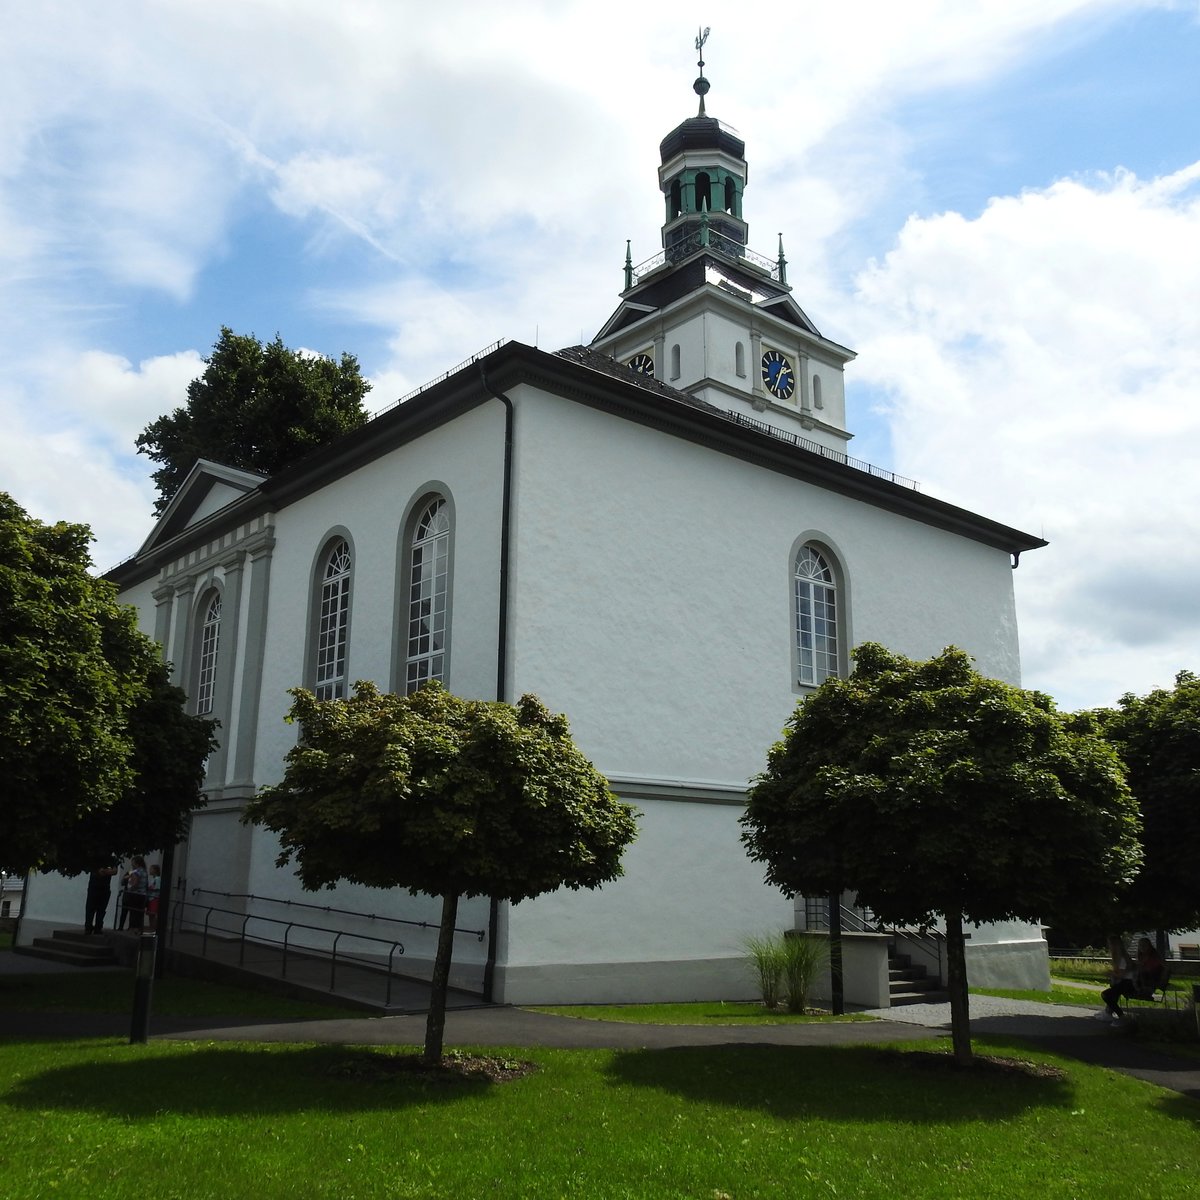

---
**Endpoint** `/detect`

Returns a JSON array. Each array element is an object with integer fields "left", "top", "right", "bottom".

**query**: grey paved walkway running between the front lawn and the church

[{"left": 0, "top": 954, "right": 1200, "bottom": 1100}]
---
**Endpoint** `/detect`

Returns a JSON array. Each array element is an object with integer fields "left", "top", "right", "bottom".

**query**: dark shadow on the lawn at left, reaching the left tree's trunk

[{"left": 5, "top": 1045, "right": 525, "bottom": 1121}]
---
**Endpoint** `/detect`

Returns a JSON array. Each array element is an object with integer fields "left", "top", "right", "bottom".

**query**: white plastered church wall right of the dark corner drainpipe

[{"left": 500, "top": 389, "right": 1044, "bottom": 1001}]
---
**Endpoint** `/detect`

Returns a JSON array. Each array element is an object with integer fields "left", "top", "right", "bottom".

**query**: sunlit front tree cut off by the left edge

[{"left": 0, "top": 493, "right": 157, "bottom": 872}]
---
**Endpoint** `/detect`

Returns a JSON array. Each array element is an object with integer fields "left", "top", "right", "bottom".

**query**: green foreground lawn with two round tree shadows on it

[{"left": 0, "top": 1039, "right": 1200, "bottom": 1200}]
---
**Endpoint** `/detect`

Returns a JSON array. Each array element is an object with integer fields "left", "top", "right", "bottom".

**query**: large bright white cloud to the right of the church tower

[{"left": 853, "top": 163, "right": 1200, "bottom": 707}]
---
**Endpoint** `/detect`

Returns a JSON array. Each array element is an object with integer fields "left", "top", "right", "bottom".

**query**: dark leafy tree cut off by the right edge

[{"left": 1094, "top": 671, "right": 1200, "bottom": 931}]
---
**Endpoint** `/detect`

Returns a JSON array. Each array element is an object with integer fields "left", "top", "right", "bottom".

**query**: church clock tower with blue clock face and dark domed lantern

[{"left": 592, "top": 30, "right": 854, "bottom": 454}]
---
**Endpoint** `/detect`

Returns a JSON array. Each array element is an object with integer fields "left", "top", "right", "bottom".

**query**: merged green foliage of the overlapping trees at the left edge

[{"left": 0, "top": 493, "right": 211, "bottom": 874}]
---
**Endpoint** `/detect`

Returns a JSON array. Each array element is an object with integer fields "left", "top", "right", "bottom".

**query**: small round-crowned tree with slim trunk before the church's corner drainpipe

[{"left": 246, "top": 683, "right": 636, "bottom": 1063}]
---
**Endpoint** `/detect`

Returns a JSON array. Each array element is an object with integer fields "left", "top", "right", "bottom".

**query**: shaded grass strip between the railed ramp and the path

[{"left": 0, "top": 968, "right": 368, "bottom": 1017}]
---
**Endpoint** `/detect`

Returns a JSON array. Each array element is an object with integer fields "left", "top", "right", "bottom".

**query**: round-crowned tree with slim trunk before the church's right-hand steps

[{"left": 742, "top": 643, "right": 1139, "bottom": 1064}]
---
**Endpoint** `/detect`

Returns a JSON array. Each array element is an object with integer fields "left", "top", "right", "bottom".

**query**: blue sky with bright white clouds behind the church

[{"left": 0, "top": 0, "right": 1200, "bottom": 708}]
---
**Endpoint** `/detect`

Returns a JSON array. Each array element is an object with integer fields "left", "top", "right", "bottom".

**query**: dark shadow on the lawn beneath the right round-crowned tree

[{"left": 607, "top": 1044, "right": 1074, "bottom": 1124}]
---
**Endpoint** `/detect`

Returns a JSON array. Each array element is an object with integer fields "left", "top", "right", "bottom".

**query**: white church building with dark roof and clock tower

[{"left": 23, "top": 65, "right": 1046, "bottom": 1003}]
